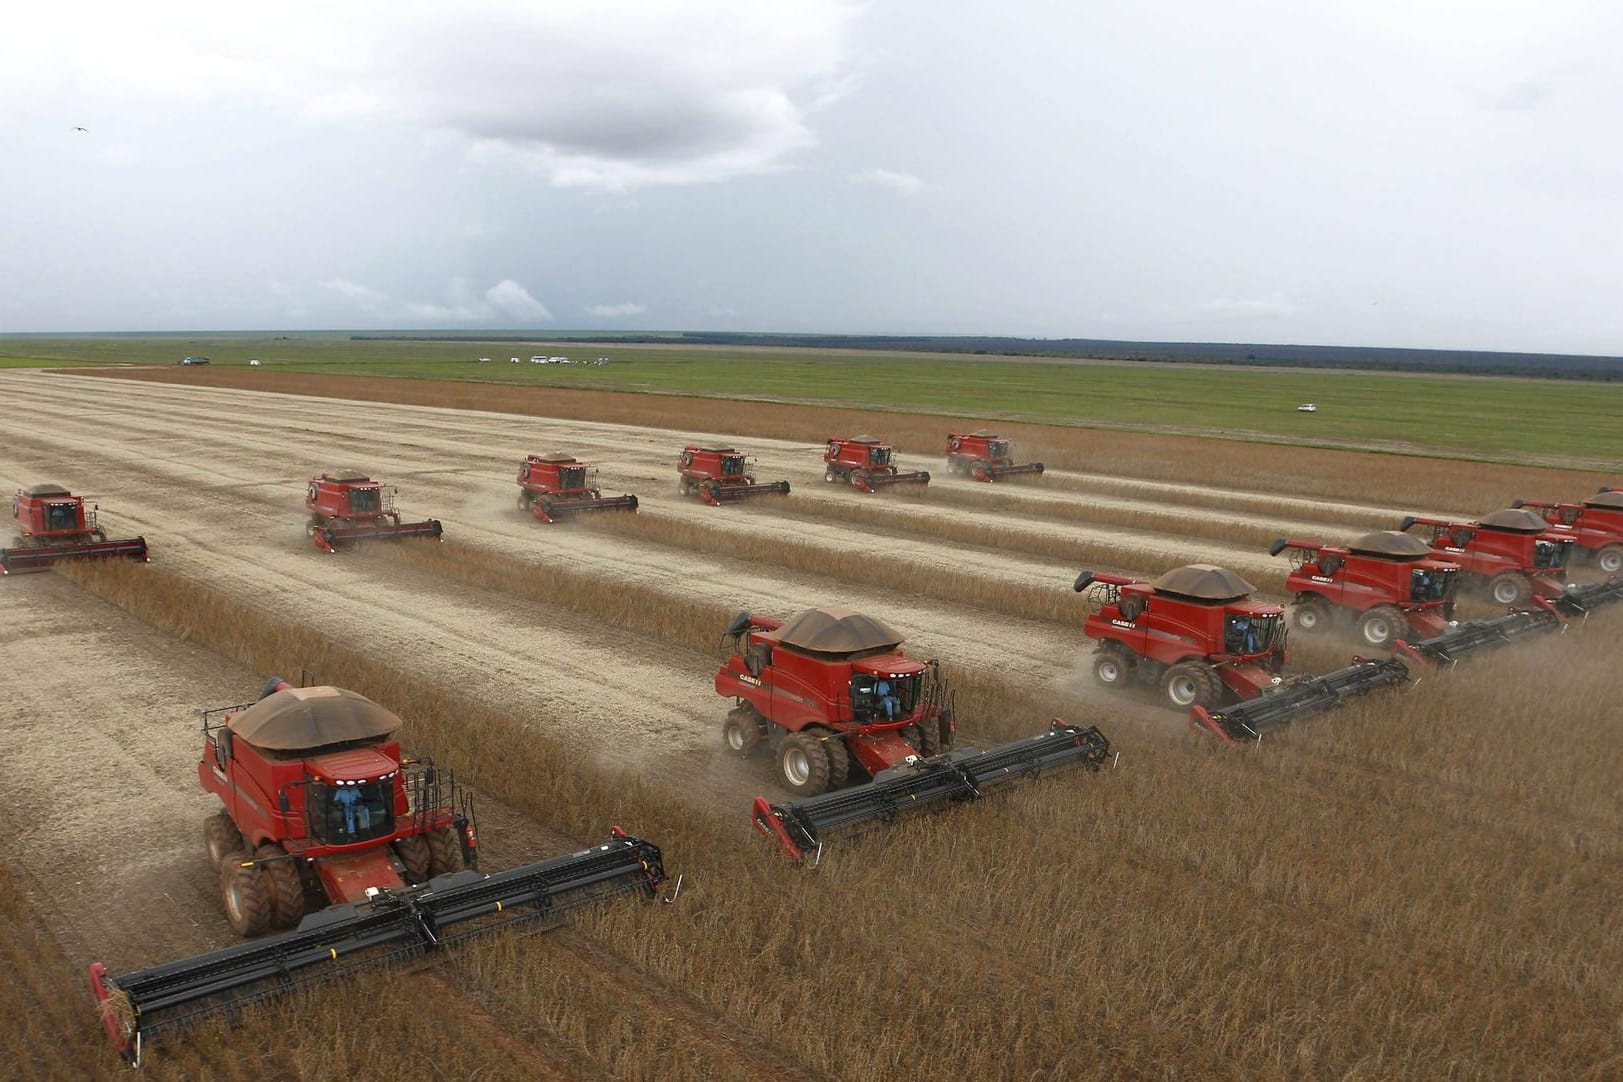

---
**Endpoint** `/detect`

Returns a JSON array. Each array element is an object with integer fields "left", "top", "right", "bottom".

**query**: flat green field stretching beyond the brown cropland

[{"left": 0, "top": 334, "right": 1623, "bottom": 469}]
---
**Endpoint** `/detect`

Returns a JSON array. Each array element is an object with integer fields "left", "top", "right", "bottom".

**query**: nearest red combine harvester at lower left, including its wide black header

[{"left": 91, "top": 678, "right": 665, "bottom": 1061}]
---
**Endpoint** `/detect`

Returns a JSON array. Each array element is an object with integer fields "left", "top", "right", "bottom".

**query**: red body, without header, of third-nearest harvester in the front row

[{"left": 1073, "top": 563, "right": 1285, "bottom": 711}]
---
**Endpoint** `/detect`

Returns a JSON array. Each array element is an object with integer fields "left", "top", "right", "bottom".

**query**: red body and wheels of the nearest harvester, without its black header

[{"left": 198, "top": 678, "right": 477, "bottom": 936}]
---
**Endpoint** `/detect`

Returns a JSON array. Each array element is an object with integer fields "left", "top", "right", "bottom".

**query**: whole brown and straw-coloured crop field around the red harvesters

[{"left": 0, "top": 371, "right": 1623, "bottom": 1079}]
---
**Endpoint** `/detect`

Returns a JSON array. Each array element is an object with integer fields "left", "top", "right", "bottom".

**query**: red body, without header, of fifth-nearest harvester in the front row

[{"left": 1397, "top": 508, "right": 1573, "bottom": 607}]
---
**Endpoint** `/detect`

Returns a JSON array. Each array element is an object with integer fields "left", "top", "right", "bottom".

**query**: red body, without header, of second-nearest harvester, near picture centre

[{"left": 716, "top": 608, "right": 954, "bottom": 796}]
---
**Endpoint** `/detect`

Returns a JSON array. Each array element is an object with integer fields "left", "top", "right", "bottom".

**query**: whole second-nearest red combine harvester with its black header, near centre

[{"left": 716, "top": 608, "right": 1110, "bottom": 858}]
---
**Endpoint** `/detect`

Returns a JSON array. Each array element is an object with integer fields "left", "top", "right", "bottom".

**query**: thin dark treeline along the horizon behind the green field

[{"left": 351, "top": 331, "right": 1623, "bottom": 380}]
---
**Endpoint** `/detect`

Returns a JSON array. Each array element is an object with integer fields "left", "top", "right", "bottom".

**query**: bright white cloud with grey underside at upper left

[{"left": 0, "top": 0, "right": 859, "bottom": 190}]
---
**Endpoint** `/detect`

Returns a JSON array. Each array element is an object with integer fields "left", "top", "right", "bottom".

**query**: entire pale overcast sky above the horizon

[{"left": 0, "top": 0, "right": 1623, "bottom": 354}]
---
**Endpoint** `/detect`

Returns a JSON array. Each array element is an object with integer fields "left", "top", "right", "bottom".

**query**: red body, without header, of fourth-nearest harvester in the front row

[{"left": 1268, "top": 530, "right": 1459, "bottom": 647}]
